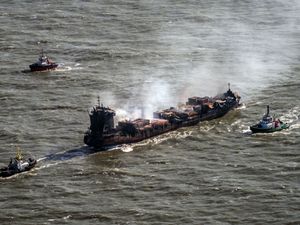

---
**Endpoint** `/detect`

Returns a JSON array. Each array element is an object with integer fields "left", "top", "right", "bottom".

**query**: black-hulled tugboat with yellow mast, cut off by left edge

[{"left": 0, "top": 148, "right": 37, "bottom": 177}]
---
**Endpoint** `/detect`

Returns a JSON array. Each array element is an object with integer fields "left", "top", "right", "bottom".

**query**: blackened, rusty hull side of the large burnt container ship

[{"left": 84, "top": 101, "right": 239, "bottom": 148}]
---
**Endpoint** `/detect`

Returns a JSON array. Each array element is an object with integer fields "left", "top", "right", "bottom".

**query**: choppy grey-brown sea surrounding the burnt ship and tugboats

[{"left": 0, "top": 0, "right": 300, "bottom": 225}]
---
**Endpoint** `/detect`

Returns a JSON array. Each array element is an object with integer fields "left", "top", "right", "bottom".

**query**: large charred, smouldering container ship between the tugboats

[{"left": 84, "top": 84, "right": 240, "bottom": 148}]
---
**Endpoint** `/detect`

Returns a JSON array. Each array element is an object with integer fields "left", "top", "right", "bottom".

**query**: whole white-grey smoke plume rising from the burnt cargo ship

[{"left": 91, "top": 1, "right": 300, "bottom": 119}]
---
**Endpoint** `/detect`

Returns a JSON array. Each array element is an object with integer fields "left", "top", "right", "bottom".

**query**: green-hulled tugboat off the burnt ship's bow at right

[{"left": 250, "top": 106, "right": 289, "bottom": 133}]
